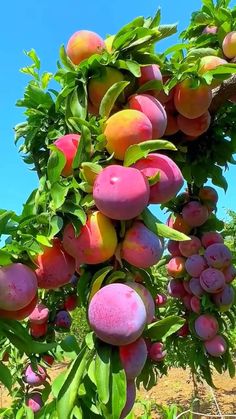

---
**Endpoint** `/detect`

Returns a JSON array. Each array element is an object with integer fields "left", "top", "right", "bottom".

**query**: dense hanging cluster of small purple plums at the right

[{"left": 167, "top": 186, "right": 236, "bottom": 357}]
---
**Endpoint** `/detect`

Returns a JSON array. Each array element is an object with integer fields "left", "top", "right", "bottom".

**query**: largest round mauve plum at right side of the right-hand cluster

[{"left": 204, "top": 243, "right": 232, "bottom": 269}]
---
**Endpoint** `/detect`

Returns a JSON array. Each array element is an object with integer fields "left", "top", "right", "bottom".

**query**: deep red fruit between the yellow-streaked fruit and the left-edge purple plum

[{"left": 35, "top": 238, "right": 75, "bottom": 289}]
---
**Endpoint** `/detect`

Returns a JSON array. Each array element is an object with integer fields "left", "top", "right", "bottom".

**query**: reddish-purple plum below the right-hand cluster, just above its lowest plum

[{"left": 194, "top": 314, "right": 219, "bottom": 340}]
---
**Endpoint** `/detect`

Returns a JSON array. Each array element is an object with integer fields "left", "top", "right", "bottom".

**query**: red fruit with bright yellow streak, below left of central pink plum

[{"left": 63, "top": 211, "right": 117, "bottom": 269}]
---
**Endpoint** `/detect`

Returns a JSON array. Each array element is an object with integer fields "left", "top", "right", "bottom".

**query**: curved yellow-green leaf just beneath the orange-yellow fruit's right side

[{"left": 124, "top": 140, "right": 176, "bottom": 167}]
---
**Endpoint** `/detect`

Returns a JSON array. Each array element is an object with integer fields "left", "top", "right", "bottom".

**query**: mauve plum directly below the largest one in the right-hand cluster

[{"left": 200, "top": 268, "right": 225, "bottom": 294}]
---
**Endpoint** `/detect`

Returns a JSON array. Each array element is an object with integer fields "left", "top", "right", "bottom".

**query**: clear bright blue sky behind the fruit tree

[{"left": 0, "top": 0, "right": 236, "bottom": 225}]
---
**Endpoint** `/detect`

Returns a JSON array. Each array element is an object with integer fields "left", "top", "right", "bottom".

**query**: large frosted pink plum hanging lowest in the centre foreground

[{"left": 88, "top": 283, "right": 147, "bottom": 346}]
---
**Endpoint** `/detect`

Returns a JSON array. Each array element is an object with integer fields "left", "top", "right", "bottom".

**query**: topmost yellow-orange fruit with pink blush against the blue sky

[{"left": 66, "top": 30, "right": 105, "bottom": 65}]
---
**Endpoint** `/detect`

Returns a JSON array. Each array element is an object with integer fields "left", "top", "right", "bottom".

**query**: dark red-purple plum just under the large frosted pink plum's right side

[{"left": 119, "top": 338, "right": 147, "bottom": 380}]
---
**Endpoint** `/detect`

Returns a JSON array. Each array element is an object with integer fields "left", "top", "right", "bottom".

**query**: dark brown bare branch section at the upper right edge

[{"left": 209, "top": 74, "right": 236, "bottom": 115}]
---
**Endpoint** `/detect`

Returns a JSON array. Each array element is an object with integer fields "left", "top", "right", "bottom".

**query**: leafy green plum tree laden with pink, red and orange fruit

[{"left": 0, "top": 0, "right": 236, "bottom": 419}]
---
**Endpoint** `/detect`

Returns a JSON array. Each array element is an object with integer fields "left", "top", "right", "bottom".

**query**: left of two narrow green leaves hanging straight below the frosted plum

[{"left": 95, "top": 344, "right": 111, "bottom": 404}]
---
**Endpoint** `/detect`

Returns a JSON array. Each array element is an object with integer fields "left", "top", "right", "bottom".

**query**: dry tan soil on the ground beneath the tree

[{"left": 0, "top": 364, "right": 236, "bottom": 419}]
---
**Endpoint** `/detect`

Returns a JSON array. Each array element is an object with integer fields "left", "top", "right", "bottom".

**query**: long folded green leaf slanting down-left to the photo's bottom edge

[{"left": 57, "top": 347, "right": 93, "bottom": 419}]
